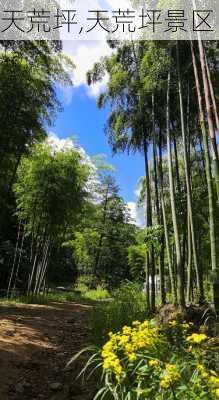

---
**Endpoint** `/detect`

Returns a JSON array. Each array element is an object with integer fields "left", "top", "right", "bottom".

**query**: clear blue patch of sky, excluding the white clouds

[{"left": 51, "top": 85, "right": 144, "bottom": 202}]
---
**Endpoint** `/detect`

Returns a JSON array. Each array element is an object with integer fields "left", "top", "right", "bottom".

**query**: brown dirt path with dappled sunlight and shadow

[{"left": 0, "top": 303, "right": 93, "bottom": 400}]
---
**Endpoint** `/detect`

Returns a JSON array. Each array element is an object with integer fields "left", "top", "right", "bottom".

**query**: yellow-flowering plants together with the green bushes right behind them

[{"left": 70, "top": 283, "right": 219, "bottom": 400}]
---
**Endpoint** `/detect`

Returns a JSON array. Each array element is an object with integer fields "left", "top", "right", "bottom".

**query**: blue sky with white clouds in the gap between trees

[{"left": 50, "top": 40, "right": 147, "bottom": 224}]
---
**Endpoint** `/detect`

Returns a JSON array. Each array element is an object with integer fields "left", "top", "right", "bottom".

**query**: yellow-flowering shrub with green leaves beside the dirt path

[{"left": 72, "top": 320, "right": 219, "bottom": 400}]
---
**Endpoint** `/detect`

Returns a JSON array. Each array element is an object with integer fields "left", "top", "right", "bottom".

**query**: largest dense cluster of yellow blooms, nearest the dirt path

[{"left": 101, "top": 321, "right": 159, "bottom": 380}]
